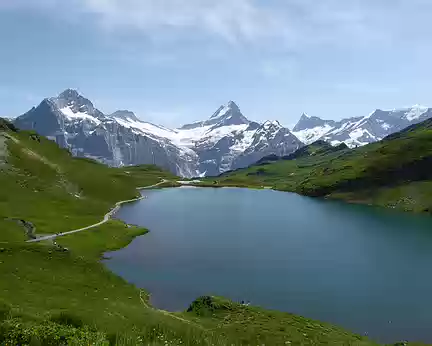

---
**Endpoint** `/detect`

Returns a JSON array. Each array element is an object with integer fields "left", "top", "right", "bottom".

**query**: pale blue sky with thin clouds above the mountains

[{"left": 0, "top": 0, "right": 432, "bottom": 126}]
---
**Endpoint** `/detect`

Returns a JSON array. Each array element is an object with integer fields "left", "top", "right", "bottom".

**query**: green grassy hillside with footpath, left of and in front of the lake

[{"left": 0, "top": 120, "right": 418, "bottom": 346}]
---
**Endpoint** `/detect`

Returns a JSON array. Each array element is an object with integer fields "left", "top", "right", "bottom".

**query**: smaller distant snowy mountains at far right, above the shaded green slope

[{"left": 293, "top": 105, "right": 432, "bottom": 148}]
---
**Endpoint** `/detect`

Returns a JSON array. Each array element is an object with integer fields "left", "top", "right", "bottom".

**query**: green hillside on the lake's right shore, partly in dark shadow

[{"left": 206, "top": 120, "right": 432, "bottom": 213}]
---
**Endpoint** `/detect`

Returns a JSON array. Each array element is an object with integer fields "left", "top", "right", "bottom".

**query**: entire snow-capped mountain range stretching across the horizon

[{"left": 14, "top": 89, "right": 432, "bottom": 177}]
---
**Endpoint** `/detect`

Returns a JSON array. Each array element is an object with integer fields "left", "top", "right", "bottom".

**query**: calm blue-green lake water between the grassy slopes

[{"left": 104, "top": 187, "right": 432, "bottom": 342}]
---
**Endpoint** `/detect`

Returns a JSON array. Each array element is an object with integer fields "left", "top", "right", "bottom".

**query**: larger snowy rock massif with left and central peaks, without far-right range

[{"left": 14, "top": 89, "right": 303, "bottom": 177}]
